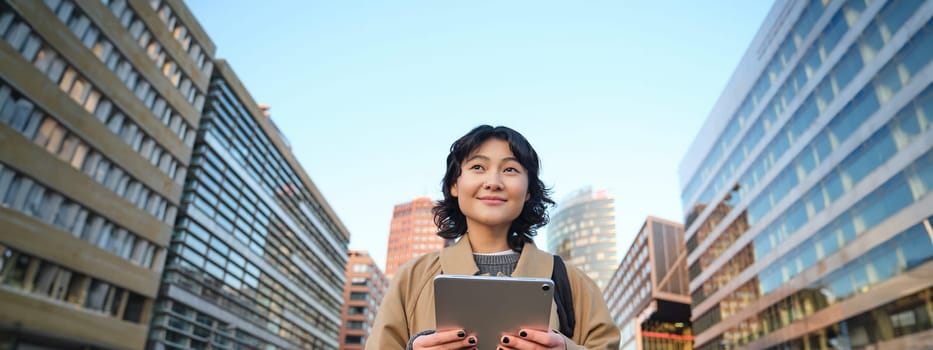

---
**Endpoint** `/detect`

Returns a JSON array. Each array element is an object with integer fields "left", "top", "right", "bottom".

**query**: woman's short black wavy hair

[{"left": 433, "top": 125, "right": 554, "bottom": 252}]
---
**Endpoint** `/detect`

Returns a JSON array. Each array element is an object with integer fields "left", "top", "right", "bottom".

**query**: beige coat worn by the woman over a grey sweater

[{"left": 366, "top": 235, "right": 620, "bottom": 349}]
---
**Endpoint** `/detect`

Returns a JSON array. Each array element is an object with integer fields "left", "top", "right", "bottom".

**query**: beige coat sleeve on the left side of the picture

[{"left": 365, "top": 270, "right": 409, "bottom": 350}]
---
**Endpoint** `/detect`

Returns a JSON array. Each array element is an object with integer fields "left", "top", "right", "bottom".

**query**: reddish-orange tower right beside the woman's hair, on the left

[{"left": 386, "top": 197, "right": 444, "bottom": 278}]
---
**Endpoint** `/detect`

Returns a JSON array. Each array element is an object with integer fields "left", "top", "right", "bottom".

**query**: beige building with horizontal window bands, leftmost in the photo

[{"left": 0, "top": 0, "right": 214, "bottom": 349}]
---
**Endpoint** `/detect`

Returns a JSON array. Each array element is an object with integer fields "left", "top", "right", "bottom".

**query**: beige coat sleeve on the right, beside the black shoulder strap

[{"left": 565, "top": 267, "right": 622, "bottom": 350}]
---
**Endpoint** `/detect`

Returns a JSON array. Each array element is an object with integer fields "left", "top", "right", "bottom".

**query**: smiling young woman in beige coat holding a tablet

[{"left": 366, "top": 125, "right": 620, "bottom": 349}]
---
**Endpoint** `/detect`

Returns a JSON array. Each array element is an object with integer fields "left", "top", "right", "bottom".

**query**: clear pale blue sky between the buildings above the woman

[{"left": 188, "top": 0, "right": 772, "bottom": 267}]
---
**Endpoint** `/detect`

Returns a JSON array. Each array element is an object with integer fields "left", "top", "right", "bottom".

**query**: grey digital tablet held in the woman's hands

[{"left": 434, "top": 275, "right": 554, "bottom": 349}]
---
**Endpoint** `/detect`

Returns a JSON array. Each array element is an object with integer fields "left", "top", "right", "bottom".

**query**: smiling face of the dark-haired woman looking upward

[{"left": 450, "top": 138, "right": 530, "bottom": 233}]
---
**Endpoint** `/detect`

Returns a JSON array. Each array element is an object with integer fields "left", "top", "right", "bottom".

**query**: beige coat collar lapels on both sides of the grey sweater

[{"left": 440, "top": 234, "right": 554, "bottom": 278}]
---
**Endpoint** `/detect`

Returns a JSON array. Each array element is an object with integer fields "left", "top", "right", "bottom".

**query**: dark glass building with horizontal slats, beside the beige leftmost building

[{"left": 150, "top": 60, "right": 349, "bottom": 349}]
